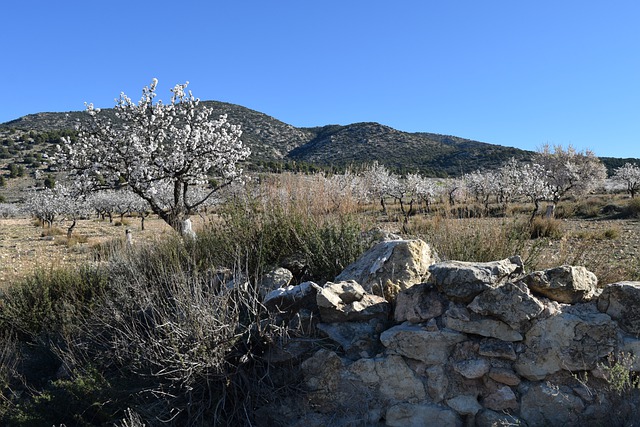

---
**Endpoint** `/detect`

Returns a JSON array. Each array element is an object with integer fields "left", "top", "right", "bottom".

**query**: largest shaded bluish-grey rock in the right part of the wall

[{"left": 514, "top": 303, "right": 618, "bottom": 380}]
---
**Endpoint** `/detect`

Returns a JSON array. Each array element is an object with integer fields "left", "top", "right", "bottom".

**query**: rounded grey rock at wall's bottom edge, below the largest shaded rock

[{"left": 520, "top": 381, "right": 584, "bottom": 426}]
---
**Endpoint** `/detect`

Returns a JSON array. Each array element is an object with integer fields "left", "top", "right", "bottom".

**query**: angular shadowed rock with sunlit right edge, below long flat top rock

[{"left": 469, "top": 282, "right": 544, "bottom": 332}]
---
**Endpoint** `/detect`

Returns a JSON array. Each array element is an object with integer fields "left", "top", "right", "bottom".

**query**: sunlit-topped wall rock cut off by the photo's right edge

[{"left": 598, "top": 282, "right": 640, "bottom": 336}]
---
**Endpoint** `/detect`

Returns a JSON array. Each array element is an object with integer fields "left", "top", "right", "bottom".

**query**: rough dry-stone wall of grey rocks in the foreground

[{"left": 256, "top": 240, "right": 640, "bottom": 427}]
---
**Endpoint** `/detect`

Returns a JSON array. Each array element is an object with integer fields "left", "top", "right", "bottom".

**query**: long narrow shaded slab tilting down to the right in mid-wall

[{"left": 443, "top": 308, "right": 523, "bottom": 341}]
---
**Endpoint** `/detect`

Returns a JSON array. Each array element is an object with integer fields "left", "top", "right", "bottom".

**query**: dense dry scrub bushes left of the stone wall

[{"left": 0, "top": 176, "right": 364, "bottom": 425}]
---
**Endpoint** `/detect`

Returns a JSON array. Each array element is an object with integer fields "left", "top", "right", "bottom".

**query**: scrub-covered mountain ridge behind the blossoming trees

[{"left": 0, "top": 101, "right": 619, "bottom": 176}]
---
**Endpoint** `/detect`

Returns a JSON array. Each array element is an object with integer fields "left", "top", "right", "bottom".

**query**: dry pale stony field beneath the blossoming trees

[{"left": 0, "top": 201, "right": 640, "bottom": 289}]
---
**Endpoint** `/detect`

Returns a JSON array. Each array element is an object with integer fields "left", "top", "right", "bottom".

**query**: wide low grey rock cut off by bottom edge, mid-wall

[{"left": 385, "top": 403, "right": 462, "bottom": 427}]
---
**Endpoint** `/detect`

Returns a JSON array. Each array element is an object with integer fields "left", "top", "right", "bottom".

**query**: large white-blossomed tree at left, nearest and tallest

[{"left": 57, "top": 79, "right": 250, "bottom": 232}]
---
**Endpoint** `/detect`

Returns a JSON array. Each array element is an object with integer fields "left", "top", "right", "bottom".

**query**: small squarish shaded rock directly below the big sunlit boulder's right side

[{"left": 393, "top": 283, "right": 447, "bottom": 323}]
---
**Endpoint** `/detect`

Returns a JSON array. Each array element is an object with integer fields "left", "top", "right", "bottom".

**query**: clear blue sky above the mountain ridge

[{"left": 0, "top": 0, "right": 640, "bottom": 158}]
